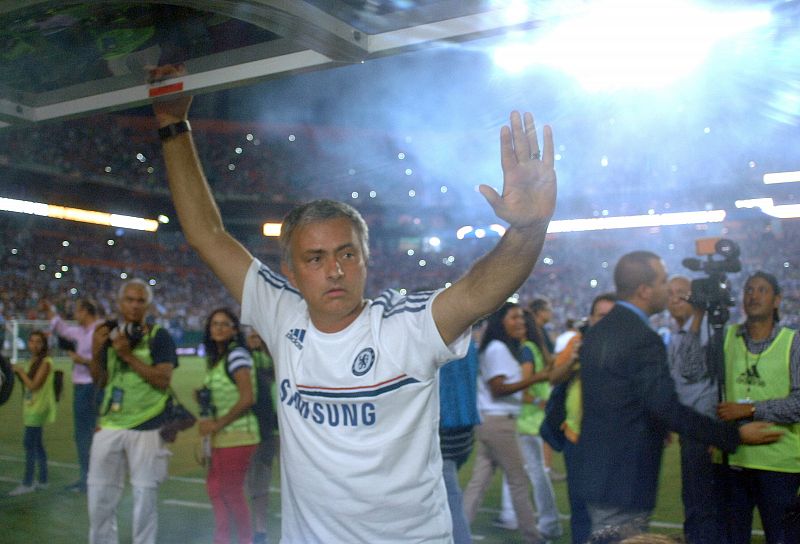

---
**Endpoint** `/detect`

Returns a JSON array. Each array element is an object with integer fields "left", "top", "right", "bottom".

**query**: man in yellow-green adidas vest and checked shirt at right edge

[{"left": 717, "top": 271, "right": 800, "bottom": 544}]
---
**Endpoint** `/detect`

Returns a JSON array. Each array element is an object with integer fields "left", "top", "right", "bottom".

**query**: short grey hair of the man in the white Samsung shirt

[{"left": 278, "top": 199, "right": 369, "bottom": 267}]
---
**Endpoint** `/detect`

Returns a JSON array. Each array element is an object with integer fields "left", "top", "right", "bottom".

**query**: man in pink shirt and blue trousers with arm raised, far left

[{"left": 40, "top": 298, "right": 102, "bottom": 493}]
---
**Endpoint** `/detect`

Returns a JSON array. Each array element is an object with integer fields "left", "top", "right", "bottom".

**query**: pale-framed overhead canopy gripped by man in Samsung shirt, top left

[{"left": 0, "top": 0, "right": 535, "bottom": 128}]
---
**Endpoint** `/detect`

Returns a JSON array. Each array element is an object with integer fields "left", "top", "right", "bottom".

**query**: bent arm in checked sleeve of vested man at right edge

[{"left": 717, "top": 333, "right": 800, "bottom": 423}]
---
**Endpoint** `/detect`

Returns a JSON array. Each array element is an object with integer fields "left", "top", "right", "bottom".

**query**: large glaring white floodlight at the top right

[{"left": 494, "top": 0, "right": 771, "bottom": 91}]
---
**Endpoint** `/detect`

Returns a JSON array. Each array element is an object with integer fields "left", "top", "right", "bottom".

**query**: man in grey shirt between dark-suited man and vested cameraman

[{"left": 667, "top": 276, "right": 719, "bottom": 544}]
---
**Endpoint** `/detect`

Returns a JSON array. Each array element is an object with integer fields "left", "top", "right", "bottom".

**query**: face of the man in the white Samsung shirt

[{"left": 284, "top": 217, "right": 367, "bottom": 332}]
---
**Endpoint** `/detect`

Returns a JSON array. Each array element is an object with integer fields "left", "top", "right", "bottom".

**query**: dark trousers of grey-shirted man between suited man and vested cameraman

[{"left": 680, "top": 436, "right": 720, "bottom": 544}]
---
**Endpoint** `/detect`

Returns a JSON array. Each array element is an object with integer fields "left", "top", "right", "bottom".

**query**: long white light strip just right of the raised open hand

[{"left": 547, "top": 210, "right": 726, "bottom": 233}]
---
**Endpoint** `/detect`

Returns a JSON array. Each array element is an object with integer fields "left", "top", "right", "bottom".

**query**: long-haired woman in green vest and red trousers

[{"left": 198, "top": 308, "right": 261, "bottom": 544}]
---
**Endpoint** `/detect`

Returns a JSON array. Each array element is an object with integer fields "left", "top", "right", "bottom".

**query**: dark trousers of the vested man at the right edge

[{"left": 718, "top": 465, "right": 800, "bottom": 544}]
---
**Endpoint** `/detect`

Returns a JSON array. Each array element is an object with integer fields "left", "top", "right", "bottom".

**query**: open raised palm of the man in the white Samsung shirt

[{"left": 479, "top": 111, "right": 556, "bottom": 227}]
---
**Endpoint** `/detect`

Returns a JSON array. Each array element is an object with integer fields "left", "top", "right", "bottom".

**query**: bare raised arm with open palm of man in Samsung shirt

[{"left": 431, "top": 112, "right": 556, "bottom": 344}]
